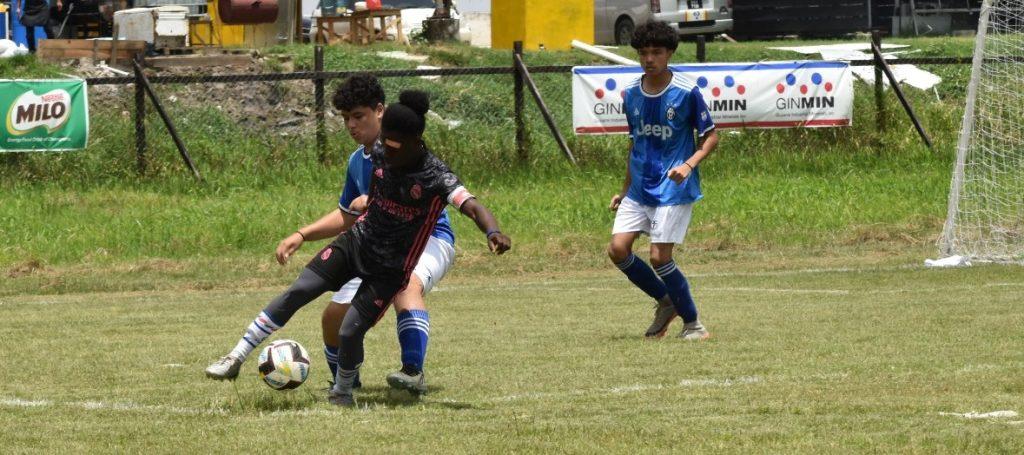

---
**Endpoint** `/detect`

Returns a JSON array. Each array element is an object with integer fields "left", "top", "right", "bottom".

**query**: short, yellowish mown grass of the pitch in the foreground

[{"left": 0, "top": 258, "right": 1024, "bottom": 453}]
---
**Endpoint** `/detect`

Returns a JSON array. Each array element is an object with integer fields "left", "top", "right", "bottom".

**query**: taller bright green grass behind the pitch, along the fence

[{"left": 0, "top": 35, "right": 970, "bottom": 270}]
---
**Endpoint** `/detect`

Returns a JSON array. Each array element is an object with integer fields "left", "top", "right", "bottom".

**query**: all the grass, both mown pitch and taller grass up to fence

[{"left": 0, "top": 34, "right": 1024, "bottom": 453}]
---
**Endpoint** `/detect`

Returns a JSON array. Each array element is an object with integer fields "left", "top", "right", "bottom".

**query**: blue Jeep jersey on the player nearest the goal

[{"left": 624, "top": 73, "right": 715, "bottom": 206}]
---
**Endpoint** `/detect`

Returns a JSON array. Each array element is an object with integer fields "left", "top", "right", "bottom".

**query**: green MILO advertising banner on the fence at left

[{"left": 0, "top": 79, "right": 89, "bottom": 152}]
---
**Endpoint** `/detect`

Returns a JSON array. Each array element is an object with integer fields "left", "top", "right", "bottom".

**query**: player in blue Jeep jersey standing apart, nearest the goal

[{"left": 608, "top": 22, "right": 718, "bottom": 340}]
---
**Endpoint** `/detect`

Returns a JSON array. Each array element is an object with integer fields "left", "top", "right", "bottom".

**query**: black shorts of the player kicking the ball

[{"left": 306, "top": 233, "right": 409, "bottom": 323}]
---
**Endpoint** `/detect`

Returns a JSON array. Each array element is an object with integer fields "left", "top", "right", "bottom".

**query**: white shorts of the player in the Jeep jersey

[{"left": 611, "top": 198, "right": 693, "bottom": 243}]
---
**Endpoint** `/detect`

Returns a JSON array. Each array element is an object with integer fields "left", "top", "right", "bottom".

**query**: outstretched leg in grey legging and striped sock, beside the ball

[{"left": 206, "top": 267, "right": 338, "bottom": 379}]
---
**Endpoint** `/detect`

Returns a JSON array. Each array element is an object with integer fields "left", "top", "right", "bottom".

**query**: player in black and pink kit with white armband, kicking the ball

[{"left": 220, "top": 91, "right": 511, "bottom": 407}]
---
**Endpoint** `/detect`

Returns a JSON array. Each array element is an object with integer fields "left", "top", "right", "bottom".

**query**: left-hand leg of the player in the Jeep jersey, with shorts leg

[{"left": 608, "top": 198, "right": 676, "bottom": 338}]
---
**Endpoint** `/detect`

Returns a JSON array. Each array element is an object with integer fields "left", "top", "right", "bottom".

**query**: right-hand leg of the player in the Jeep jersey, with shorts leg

[{"left": 650, "top": 204, "right": 711, "bottom": 340}]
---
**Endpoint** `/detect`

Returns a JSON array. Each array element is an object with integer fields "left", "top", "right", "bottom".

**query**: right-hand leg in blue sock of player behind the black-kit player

[{"left": 387, "top": 237, "right": 455, "bottom": 394}]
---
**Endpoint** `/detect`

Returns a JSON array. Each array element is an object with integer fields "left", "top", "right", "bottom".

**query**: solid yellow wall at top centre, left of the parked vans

[{"left": 490, "top": 0, "right": 594, "bottom": 49}]
